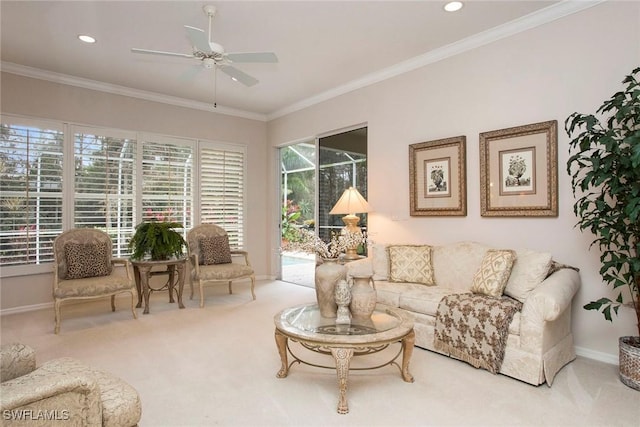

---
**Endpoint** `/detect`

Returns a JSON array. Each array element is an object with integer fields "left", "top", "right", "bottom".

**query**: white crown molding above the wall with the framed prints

[{"left": 267, "top": 0, "right": 607, "bottom": 120}]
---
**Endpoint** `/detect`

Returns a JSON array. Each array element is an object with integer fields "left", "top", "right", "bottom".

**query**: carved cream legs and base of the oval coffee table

[{"left": 275, "top": 328, "right": 416, "bottom": 414}]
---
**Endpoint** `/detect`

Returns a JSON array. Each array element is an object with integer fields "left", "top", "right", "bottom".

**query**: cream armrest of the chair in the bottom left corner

[{"left": 0, "top": 368, "right": 102, "bottom": 426}]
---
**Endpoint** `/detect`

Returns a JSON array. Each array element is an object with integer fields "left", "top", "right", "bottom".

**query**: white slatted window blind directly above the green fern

[{"left": 142, "top": 141, "right": 195, "bottom": 233}]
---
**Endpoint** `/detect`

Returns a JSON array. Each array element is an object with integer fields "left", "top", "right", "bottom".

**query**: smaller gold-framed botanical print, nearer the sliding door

[{"left": 409, "top": 136, "right": 467, "bottom": 216}]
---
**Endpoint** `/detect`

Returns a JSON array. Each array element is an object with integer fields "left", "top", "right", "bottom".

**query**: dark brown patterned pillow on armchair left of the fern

[{"left": 64, "top": 242, "right": 113, "bottom": 279}]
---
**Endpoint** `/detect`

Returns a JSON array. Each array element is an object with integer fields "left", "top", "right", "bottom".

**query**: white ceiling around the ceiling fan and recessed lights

[{"left": 0, "top": 0, "right": 596, "bottom": 118}]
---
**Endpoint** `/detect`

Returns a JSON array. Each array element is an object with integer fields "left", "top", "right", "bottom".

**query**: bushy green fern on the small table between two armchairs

[{"left": 129, "top": 220, "right": 187, "bottom": 261}]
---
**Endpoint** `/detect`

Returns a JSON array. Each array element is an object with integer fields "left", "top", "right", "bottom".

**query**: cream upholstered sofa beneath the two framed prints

[{"left": 346, "top": 242, "right": 580, "bottom": 385}]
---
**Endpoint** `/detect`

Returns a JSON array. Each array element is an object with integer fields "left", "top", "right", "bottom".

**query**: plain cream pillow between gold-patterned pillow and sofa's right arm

[{"left": 504, "top": 249, "right": 551, "bottom": 303}]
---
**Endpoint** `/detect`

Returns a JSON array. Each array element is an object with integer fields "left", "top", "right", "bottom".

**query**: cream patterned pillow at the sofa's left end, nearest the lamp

[{"left": 387, "top": 245, "right": 435, "bottom": 286}]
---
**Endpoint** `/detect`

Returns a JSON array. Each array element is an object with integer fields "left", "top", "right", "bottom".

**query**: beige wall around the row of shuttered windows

[{"left": 0, "top": 73, "right": 269, "bottom": 310}]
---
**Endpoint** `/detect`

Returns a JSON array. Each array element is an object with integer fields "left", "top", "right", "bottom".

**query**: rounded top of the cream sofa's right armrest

[{"left": 522, "top": 268, "right": 580, "bottom": 322}]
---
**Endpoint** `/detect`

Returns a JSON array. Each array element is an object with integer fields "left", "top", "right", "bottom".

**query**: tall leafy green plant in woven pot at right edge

[{"left": 565, "top": 67, "right": 640, "bottom": 390}]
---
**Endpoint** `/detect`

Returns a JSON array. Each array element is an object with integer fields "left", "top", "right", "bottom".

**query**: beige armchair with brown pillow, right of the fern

[{"left": 187, "top": 224, "right": 256, "bottom": 308}]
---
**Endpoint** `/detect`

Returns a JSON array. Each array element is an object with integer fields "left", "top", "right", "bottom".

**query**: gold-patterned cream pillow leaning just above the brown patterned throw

[{"left": 471, "top": 249, "right": 516, "bottom": 297}]
